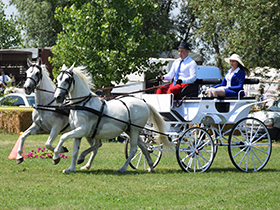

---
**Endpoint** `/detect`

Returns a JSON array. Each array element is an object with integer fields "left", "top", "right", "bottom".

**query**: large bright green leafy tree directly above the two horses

[{"left": 52, "top": 0, "right": 168, "bottom": 87}]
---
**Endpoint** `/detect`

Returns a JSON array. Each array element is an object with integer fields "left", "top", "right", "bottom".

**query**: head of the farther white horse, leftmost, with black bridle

[{"left": 23, "top": 59, "right": 42, "bottom": 95}]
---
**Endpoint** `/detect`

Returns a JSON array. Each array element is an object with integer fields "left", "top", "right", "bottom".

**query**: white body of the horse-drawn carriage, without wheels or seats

[{"left": 142, "top": 94, "right": 258, "bottom": 132}]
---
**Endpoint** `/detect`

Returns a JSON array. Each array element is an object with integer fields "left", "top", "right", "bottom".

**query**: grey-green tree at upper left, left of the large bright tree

[{"left": 10, "top": 0, "right": 69, "bottom": 48}]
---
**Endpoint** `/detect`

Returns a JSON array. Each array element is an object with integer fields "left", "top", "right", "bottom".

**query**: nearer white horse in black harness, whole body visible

[{"left": 53, "top": 65, "right": 170, "bottom": 173}]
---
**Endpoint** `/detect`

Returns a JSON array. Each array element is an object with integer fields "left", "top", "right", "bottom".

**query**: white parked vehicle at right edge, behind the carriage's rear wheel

[{"left": 250, "top": 99, "right": 280, "bottom": 141}]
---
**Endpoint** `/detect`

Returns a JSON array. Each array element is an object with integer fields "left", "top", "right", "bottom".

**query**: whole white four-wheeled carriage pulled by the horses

[{"left": 125, "top": 80, "right": 272, "bottom": 172}]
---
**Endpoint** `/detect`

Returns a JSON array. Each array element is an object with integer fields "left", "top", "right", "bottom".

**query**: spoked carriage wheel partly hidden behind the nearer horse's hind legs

[{"left": 125, "top": 137, "right": 162, "bottom": 170}]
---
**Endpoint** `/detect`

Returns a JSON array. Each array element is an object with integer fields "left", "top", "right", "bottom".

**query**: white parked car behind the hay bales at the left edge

[{"left": 0, "top": 93, "right": 35, "bottom": 107}]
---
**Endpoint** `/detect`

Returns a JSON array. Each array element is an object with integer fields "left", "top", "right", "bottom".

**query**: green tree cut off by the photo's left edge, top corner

[{"left": 0, "top": 1, "right": 21, "bottom": 49}]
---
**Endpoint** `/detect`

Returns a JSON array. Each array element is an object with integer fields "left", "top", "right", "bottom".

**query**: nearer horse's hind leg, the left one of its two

[{"left": 116, "top": 129, "right": 140, "bottom": 173}]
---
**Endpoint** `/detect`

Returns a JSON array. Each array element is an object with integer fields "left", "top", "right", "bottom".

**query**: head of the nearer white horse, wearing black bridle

[{"left": 54, "top": 64, "right": 74, "bottom": 103}]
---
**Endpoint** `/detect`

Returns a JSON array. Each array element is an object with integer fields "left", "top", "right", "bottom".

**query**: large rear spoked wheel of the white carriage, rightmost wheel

[{"left": 228, "top": 118, "right": 272, "bottom": 172}]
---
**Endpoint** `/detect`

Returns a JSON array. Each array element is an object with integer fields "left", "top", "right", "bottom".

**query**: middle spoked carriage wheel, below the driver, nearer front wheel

[{"left": 176, "top": 127, "right": 215, "bottom": 172}]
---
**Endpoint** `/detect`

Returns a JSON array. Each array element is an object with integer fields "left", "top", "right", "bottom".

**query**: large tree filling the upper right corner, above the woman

[{"left": 189, "top": 0, "right": 280, "bottom": 74}]
